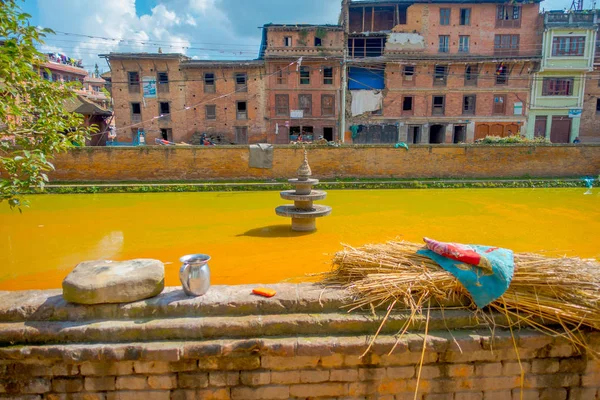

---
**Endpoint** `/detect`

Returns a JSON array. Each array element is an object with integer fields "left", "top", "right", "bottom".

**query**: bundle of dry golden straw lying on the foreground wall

[{"left": 323, "top": 241, "right": 600, "bottom": 354}]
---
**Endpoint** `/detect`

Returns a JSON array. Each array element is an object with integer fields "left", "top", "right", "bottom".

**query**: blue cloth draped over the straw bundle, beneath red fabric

[{"left": 417, "top": 245, "right": 515, "bottom": 308}]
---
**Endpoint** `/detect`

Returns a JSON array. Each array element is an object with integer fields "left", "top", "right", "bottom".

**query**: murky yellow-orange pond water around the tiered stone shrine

[{"left": 0, "top": 189, "right": 600, "bottom": 290}]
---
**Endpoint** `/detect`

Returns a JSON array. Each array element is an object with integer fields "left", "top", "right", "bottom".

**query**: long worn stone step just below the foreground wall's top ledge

[{"left": 0, "top": 310, "right": 506, "bottom": 346}]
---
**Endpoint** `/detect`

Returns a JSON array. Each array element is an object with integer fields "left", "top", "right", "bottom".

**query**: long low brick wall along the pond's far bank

[{"left": 51, "top": 145, "right": 600, "bottom": 181}]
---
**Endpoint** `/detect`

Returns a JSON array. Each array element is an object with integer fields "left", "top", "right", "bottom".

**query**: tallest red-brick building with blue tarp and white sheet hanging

[{"left": 342, "top": 0, "right": 541, "bottom": 143}]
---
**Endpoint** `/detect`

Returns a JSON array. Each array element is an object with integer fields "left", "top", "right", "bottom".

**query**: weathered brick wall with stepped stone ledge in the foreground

[{"left": 0, "top": 284, "right": 600, "bottom": 400}]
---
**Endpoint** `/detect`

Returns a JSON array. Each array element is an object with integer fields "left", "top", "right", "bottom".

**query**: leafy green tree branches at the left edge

[{"left": 0, "top": 0, "right": 95, "bottom": 210}]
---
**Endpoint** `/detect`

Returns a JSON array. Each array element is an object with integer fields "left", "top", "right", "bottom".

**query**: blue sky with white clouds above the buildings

[{"left": 21, "top": 0, "right": 576, "bottom": 70}]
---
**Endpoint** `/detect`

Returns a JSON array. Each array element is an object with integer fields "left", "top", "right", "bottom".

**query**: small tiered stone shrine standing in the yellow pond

[{"left": 275, "top": 150, "right": 331, "bottom": 232}]
